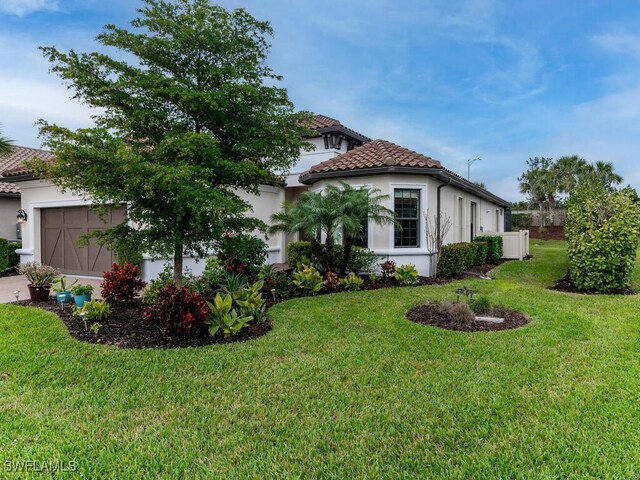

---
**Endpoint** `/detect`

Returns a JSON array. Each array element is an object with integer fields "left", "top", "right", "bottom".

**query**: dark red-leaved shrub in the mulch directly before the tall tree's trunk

[{"left": 142, "top": 283, "right": 209, "bottom": 335}]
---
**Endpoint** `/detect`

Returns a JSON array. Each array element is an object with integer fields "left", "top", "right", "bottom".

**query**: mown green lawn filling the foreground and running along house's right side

[{"left": 0, "top": 242, "right": 640, "bottom": 479}]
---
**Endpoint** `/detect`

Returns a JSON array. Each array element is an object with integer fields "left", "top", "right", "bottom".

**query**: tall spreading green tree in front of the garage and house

[{"left": 37, "top": 0, "right": 311, "bottom": 283}]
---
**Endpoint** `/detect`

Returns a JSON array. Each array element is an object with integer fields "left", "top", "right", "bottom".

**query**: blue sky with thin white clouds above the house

[{"left": 0, "top": 0, "right": 640, "bottom": 200}]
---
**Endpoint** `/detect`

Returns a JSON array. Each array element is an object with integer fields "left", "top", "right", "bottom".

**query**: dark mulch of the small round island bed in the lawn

[{"left": 407, "top": 303, "right": 529, "bottom": 332}]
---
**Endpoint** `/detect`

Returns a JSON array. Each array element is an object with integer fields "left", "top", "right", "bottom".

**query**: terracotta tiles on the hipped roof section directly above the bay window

[{"left": 300, "top": 140, "right": 442, "bottom": 178}]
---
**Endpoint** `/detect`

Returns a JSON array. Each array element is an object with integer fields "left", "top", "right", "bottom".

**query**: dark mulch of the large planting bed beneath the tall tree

[{"left": 12, "top": 299, "right": 272, "bottom": 348}]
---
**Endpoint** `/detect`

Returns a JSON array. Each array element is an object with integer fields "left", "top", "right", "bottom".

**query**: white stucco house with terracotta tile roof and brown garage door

[{"left": 0, "top": 115, "right": 511, "bottom": 280}]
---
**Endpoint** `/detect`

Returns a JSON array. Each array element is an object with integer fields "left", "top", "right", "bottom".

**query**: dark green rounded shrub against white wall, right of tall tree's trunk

[{"left": 217, "top": 232, "right": 267, "bottom": 277}]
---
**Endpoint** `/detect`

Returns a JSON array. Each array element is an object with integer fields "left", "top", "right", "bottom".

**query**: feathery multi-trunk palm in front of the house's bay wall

[{"left": 269, "top": 182, "right": 395, "bottom": 272}]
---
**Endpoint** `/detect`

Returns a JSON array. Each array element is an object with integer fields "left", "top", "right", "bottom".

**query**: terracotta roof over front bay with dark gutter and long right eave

[{"left": 300, "top": 140, "right": 511, "bottom": 207}]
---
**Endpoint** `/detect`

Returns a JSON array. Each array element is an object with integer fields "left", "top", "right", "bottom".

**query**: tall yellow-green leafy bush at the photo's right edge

[{"left": 565, "top": 187, "right": 640, "bottom": 292}]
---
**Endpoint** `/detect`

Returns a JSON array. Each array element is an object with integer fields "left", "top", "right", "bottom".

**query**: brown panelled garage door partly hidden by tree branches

[{"left": 40, "top": 207, "right": 125, "bottom": 276}]
